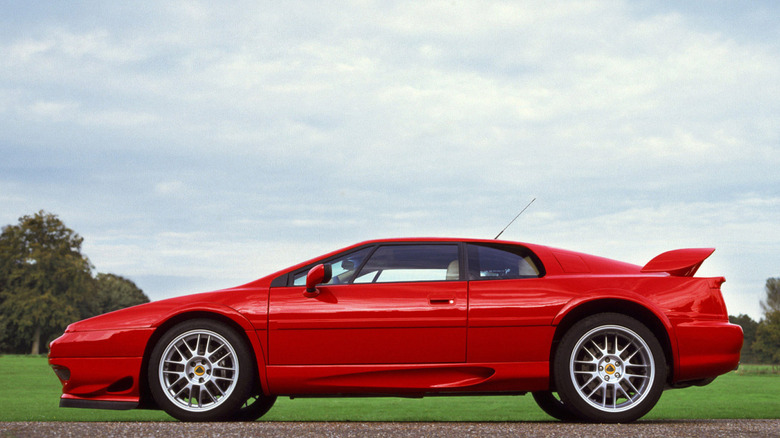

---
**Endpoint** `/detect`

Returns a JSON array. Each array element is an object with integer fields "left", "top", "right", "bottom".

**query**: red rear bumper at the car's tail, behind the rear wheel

[{"left": 674, "top": 321, "right": 743, "bottom": 383}]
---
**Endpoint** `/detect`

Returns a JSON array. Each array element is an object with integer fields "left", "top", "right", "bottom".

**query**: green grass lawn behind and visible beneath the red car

[{"left": 0, "top": 356, "right": 780, "bottom": 421}]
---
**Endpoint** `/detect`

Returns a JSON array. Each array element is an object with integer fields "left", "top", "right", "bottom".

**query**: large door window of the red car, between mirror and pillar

[{"left": 354, "top": 244, "right": 460, "bottom": 283}]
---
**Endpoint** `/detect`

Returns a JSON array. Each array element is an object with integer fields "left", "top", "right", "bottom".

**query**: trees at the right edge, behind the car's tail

[{"left": 729, "top": 278, "right": 780, "bottom": 364}]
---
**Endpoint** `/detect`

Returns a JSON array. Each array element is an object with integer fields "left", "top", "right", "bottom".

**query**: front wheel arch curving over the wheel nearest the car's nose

[{"left": 138, "top": 310, "right": 263, "bottom": 409}]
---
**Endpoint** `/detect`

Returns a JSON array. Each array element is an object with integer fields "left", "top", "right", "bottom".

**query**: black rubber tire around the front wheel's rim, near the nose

[{"left": 147, "top": 319, "right": 255, "bottom": 421}]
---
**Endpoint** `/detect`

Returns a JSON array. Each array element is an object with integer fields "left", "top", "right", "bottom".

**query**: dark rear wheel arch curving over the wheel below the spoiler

[{"left": 550, "top": 298, "right": 676, "bottom": 387}]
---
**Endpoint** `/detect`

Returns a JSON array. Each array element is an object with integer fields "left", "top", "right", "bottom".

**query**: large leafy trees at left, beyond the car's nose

[{"left": 0, "top": 210, "right": 149, "bottom": 354}]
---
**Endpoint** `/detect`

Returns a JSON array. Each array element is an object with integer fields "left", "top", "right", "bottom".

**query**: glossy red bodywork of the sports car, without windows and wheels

[{"left": 49, "top": 238, "right": 742, "bottom": 412}]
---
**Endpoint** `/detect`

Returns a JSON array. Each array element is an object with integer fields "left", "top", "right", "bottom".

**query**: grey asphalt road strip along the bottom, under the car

[{"left": 0, "top": 420, "right": 780, "bottom": 438}]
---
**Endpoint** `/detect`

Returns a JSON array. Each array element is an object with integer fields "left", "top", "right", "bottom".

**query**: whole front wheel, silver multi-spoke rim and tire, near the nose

[{"left": 147, "top": 319, "right": 255, "bottom": 421}]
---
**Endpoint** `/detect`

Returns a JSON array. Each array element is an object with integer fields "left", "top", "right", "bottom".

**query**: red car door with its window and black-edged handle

[{"left": 268, "top": 243, "right": 468, "bottom": 365}]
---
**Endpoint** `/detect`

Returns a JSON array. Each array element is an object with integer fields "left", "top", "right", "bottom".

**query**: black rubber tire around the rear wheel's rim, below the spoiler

[{"left": 553, "top": 313, "right": 667, "bottom": 423}]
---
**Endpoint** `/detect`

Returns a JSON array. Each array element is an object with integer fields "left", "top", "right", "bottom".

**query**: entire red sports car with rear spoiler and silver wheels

[{"left": 49, "top": 238, "right": 742, "bottom": 422}]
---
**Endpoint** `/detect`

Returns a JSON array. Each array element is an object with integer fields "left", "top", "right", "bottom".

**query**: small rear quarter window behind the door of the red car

[{"left": 468, "top": 244, "right": 544, "bottom": 280}]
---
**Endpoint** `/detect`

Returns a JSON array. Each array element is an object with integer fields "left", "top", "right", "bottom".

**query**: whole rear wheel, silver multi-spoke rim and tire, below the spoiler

[{"left": 553, "top": 313, "right": 667, "bottom": 423}]
